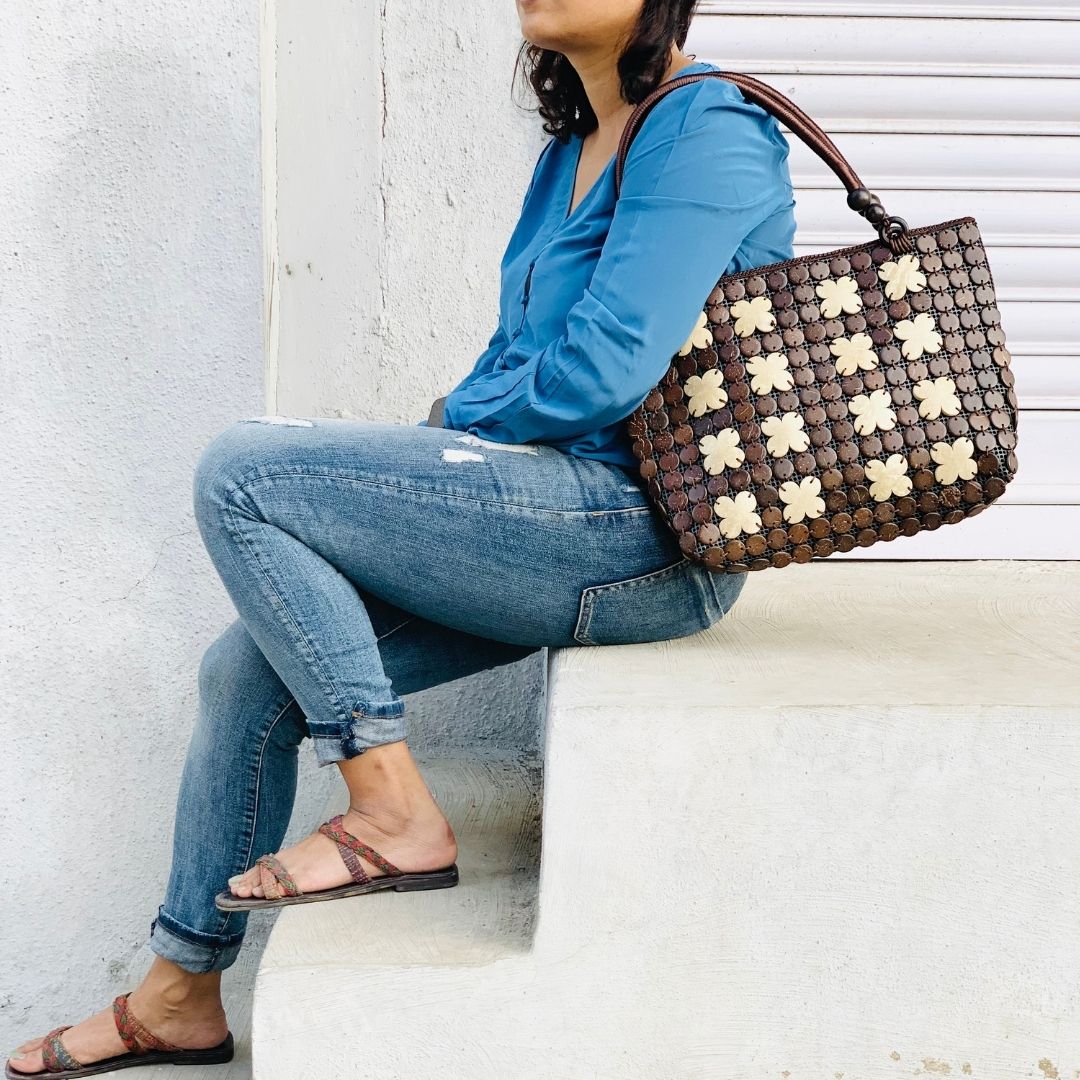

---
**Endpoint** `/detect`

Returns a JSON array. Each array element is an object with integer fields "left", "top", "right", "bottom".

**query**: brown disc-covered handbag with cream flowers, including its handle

[{"left": 615, "top": 71, "right": 1017, "bottom": 573}]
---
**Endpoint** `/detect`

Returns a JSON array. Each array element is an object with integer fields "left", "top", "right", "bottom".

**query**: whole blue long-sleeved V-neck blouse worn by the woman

[{"left": 420, "top": 60, "right": 795, "bottom": 469}]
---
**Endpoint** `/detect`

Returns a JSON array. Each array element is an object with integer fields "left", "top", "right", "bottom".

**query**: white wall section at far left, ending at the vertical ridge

[{"left": 0, "top": 0, "right": 280, "bottom": 1050}]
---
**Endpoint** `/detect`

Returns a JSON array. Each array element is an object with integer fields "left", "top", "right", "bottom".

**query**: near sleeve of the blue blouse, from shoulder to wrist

[{"left": 443, "top": 79, "right": 792, "bottom": 443}]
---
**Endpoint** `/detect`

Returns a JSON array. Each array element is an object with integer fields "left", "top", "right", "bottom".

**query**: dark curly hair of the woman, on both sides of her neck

[{"left": 515, "top": 0, "right": 698, "bottom": 143}]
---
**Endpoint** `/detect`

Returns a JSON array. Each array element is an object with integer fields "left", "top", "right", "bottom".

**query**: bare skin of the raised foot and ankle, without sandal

[{"left": 229, "top": 742, "right": 458, "bottom": 897}]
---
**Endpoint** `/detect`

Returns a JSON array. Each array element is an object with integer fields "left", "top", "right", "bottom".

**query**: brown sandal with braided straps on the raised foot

[{"left": 214, "top": 814, "right": 458, "bottom": 912}]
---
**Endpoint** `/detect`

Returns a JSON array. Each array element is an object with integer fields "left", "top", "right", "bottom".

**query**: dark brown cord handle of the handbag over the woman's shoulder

[{"left": 615, "top": 71, "right": 912, "bottom": 255}]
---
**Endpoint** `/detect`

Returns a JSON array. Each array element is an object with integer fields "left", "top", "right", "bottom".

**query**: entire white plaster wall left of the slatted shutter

[{"left": 0, "top": 0, "right": 544, "bottom": 1049}]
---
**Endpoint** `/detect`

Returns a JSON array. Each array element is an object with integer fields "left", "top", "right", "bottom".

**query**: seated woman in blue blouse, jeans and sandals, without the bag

[{"left": 8, "top": 0, "right": 795, "bottom": 1077}]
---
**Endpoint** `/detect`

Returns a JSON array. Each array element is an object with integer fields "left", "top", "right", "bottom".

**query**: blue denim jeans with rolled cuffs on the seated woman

[{"left": 150, "top": 417, "right": 745, "bottom": 972}]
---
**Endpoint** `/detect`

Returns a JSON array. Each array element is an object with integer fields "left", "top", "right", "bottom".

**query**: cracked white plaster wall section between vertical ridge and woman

[{"left": 270, "top": 0, "right": 546, "bottom": 753}]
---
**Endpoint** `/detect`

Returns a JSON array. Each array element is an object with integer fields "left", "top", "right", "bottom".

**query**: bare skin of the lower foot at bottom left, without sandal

[{"left": 8, "top": 957, "right": 229, "bottom": 1076}]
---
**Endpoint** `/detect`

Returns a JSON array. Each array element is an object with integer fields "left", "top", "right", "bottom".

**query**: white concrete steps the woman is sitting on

[{"left": 253, "top": 561, "right": 1080, "bottom": 1080}]
